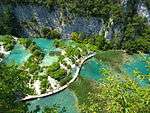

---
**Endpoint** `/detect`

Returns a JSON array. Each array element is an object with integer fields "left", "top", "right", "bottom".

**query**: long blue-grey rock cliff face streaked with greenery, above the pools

[{"left": 14, "top": 5, "right": 101, "bottom": 38}]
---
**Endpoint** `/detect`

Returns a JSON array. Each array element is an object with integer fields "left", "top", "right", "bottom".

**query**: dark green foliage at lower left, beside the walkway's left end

[{"left": 0, "top": 64, "right": 32, "bottom": 113}]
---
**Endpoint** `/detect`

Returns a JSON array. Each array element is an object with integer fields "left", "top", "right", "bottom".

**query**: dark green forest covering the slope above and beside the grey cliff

[{"left": 0, "top": 0, "right": 150, "bottom": 53}]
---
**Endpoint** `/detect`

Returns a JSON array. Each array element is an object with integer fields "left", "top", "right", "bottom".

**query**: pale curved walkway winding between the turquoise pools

[{"left": 21, "top": 53, "right": 96, "bottom": 101}]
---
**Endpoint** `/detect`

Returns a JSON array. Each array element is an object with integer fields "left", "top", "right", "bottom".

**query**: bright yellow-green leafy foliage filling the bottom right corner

[{"left": 80, "top": 70, "right": 150, "bottom": 113}]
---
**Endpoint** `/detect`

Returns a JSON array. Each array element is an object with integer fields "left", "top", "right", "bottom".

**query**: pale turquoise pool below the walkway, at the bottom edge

[{"left": 28, "top": 89, "right": 79, "bottom": 113}]
